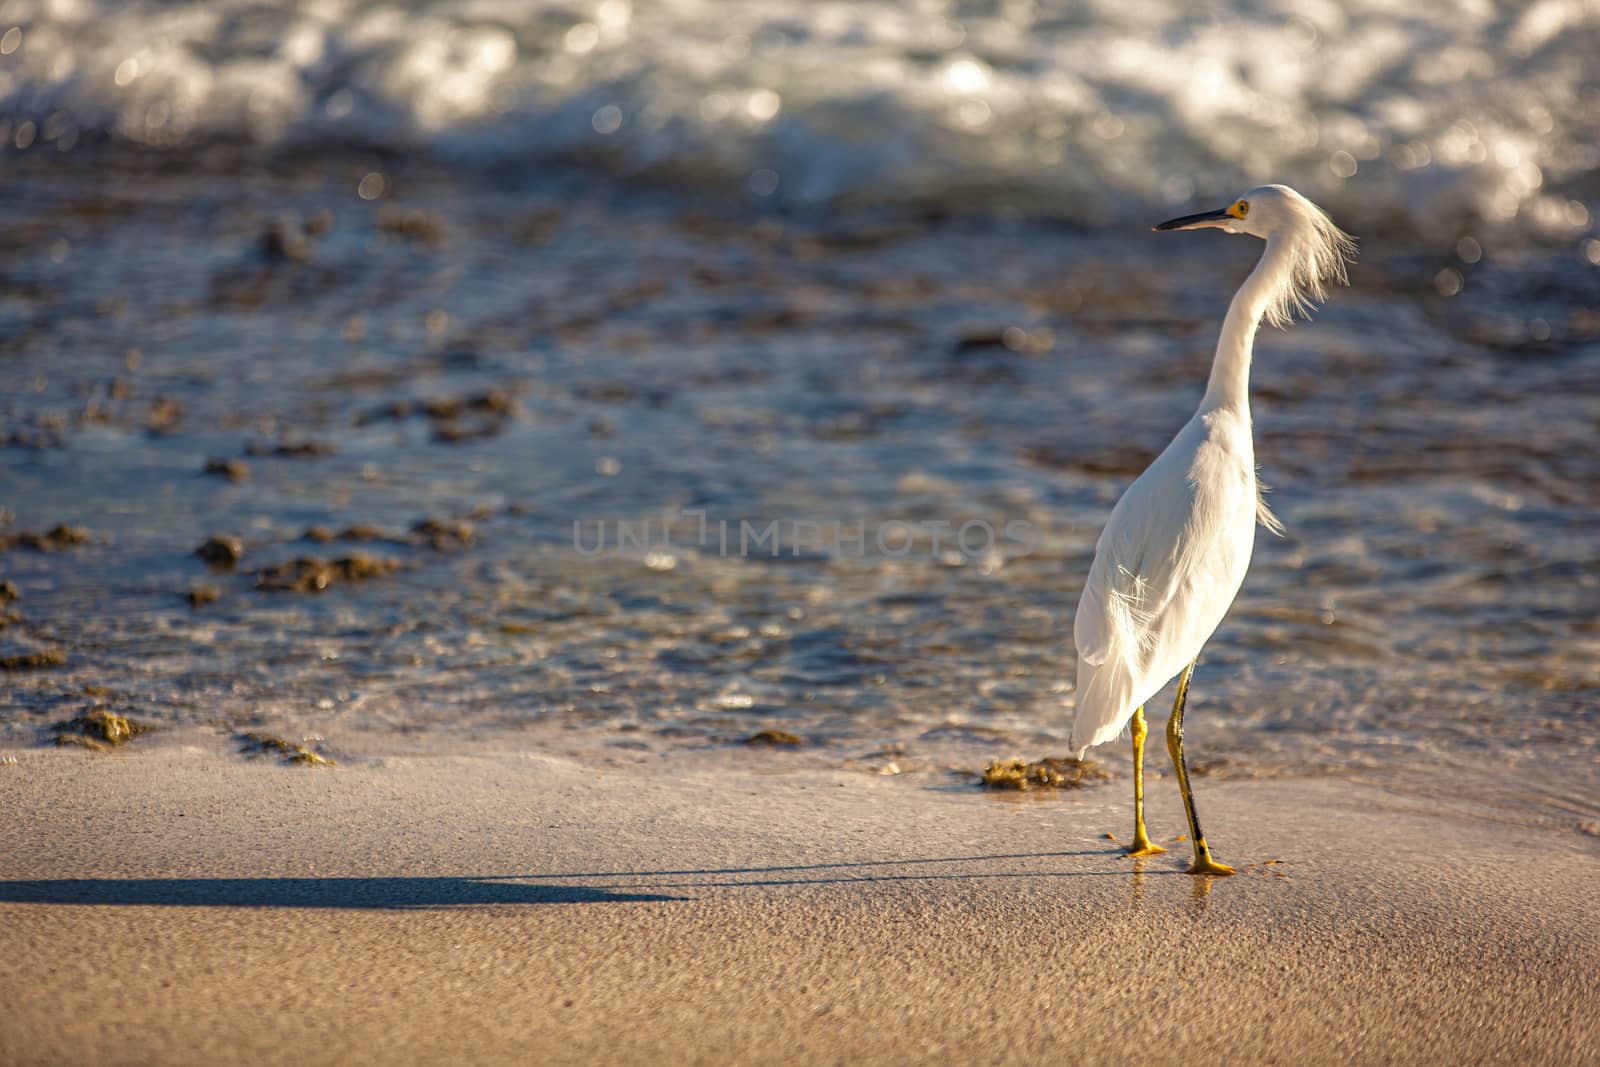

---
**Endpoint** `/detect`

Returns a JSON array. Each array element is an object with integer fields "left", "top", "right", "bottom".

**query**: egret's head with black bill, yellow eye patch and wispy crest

[{"left": 1155, "top": 186, "right": 1355, "bottom": 326}]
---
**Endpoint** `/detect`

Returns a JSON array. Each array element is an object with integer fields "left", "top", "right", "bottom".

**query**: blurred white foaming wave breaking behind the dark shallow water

[{"left": 0, "top": 0, "right": 1600, "bottom": 240}]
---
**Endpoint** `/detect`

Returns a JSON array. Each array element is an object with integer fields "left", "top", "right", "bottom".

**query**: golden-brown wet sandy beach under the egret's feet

[{"left": 0, "top": 731, "right": 1600, "bottom": 1064}]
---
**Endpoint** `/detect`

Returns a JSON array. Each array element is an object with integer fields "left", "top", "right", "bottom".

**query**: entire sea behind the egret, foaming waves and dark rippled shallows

[{"left": 0, "top": 0, "right": 1600, "bottom": 833}]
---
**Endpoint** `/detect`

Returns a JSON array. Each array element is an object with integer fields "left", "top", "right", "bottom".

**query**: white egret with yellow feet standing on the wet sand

[{"left": 1070, "top": 186, "right": 1355, "bottom": 875}]
